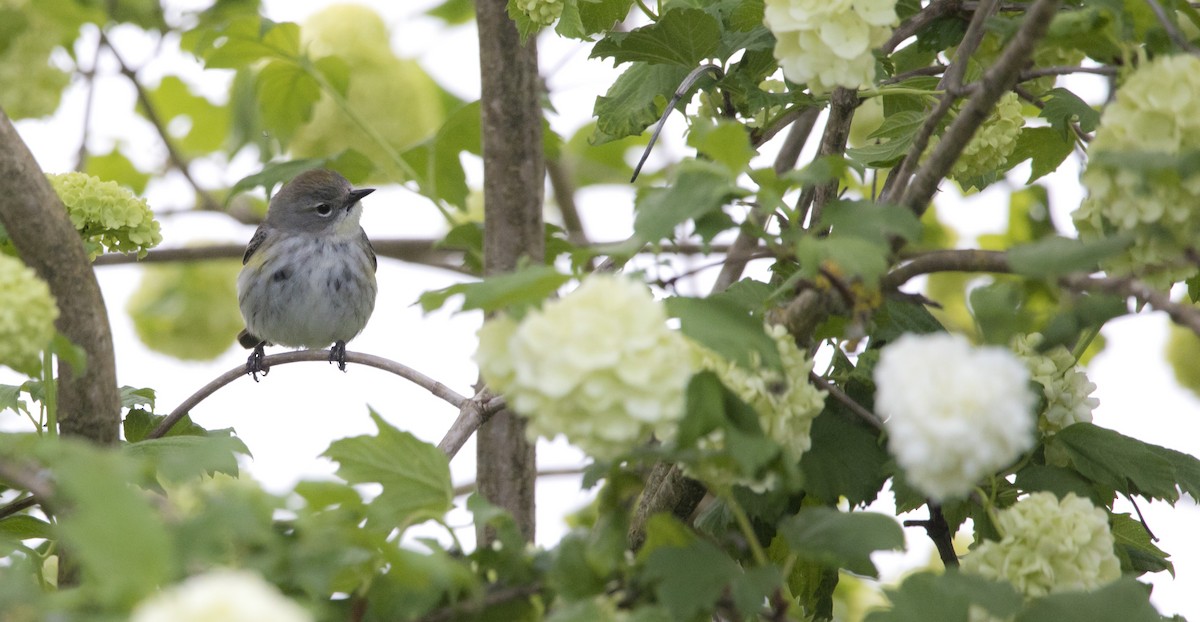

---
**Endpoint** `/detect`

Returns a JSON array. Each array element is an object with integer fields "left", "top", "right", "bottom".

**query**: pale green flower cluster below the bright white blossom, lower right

[{"left": 962, "top": 492, "right": 1121, "bottom": 598}]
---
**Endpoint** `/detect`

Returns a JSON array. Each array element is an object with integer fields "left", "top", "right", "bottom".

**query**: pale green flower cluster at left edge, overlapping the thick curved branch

[{"left": 0, "top": 255, "right": 59, "bottom": 375}]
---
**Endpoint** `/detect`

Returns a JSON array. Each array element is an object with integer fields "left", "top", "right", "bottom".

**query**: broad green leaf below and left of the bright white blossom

[{"left": 779, "top": 507, "right": 905, "bottom": 576}]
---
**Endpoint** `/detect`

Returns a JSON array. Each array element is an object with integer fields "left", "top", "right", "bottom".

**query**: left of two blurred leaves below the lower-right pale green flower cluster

[{"left": 866, "top": 569, "right": 1021, "bottom": 622}]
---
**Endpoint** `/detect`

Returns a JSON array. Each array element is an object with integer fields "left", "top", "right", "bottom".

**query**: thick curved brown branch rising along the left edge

[{"left": 0, "top": 110, "right": 121, "bottom": 444}]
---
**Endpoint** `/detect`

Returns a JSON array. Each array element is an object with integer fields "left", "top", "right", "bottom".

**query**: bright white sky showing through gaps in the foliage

[{"left": 7, "top": 0, "right": 1200, "bottom": 618}]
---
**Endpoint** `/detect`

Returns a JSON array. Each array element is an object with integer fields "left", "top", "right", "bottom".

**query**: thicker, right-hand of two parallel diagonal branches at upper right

[{"left": 892, "top": 0, "right": 1058, "bottom": 216}]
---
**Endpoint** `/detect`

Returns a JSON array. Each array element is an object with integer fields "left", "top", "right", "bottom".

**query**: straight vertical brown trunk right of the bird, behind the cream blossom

[{"left": 475, "top": 0, "right": 546, "bottom": 542}]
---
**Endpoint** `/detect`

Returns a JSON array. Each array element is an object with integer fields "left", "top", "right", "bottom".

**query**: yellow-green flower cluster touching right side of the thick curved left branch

[{"left": 46, "top": 173, "right": 162, "bottom": 259}]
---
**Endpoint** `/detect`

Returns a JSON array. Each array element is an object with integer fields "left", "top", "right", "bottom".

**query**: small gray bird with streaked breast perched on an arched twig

[{"left": 238, "top": 169, "right": 378, "bottom": 381}]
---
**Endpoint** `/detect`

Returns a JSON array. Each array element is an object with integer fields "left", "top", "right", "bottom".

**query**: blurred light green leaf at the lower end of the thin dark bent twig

[{"left": 634, "top": 161, "right": 745, "bottom": 243}]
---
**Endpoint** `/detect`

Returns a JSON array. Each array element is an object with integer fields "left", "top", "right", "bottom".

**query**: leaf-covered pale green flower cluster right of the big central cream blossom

[{"left": 690, "top": 324, "right": 826, "bottom": 488}]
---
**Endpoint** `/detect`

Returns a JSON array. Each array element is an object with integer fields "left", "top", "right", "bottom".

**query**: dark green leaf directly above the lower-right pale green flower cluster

[{"left": 1046, "top": 423, "right": 1180, "bottom": 503}]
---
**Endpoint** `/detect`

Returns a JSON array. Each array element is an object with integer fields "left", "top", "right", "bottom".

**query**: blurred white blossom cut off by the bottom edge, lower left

[{"left": 131, "top": 570, "right": 313, "bottom": 622}]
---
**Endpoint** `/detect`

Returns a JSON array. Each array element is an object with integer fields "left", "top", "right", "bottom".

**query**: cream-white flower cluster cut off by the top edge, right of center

[{"left": 764, "top": 0, "right": 899, "bottom": 92}]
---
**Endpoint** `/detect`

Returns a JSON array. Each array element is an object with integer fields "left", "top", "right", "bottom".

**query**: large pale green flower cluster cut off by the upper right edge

[{"left": 1074, "top": 54, "right": 1200, "bottom": 287}]
